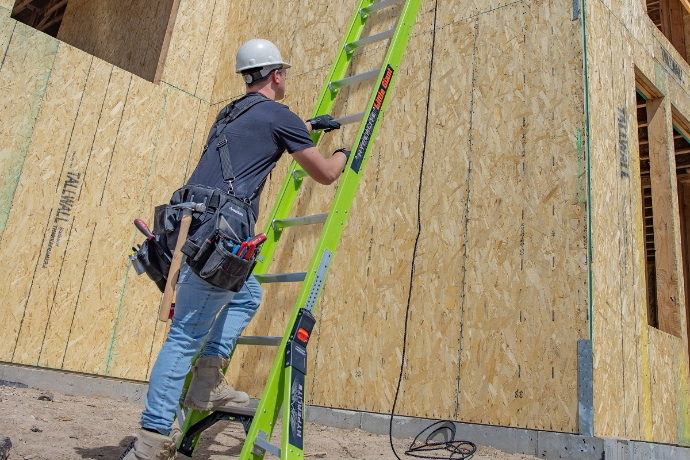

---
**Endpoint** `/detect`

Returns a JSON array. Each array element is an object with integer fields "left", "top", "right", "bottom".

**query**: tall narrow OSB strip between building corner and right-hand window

[{"left": 587, "top": 2, "right": 624, "bottom": 436}]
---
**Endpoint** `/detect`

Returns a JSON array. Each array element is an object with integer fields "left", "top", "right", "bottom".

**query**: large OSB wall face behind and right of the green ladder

[{"left": 220, "top": 2, "right": 587, "bottom": 431}]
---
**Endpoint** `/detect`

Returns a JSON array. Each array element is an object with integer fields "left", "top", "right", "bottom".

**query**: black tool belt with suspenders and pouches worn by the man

[{"left": 136, "top": 94, "right": 270, "bottom": 292}]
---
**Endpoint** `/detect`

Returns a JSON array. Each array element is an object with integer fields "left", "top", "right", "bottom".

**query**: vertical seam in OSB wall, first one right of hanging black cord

[{"left": 454, "top": 17, "right": 476, "bottom": 420}]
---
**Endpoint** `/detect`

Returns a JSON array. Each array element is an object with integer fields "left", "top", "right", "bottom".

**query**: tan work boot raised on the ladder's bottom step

[{"left": 184, "top": 356, "right": 249, "bottom": 411}]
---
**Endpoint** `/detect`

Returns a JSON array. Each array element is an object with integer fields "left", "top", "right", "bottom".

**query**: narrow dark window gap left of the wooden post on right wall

[{"left": 637, "top": 90, "right": 659, "bottom": 328}]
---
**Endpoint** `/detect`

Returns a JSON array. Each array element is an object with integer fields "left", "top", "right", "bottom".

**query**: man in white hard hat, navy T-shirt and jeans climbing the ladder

[{"left": 122, "top": 39, "right": 349, "bottom": 460}]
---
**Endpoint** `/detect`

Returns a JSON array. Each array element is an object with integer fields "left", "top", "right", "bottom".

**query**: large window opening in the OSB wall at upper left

[{"left": 12, "top": 0, "right": 180, "bottom": 83}]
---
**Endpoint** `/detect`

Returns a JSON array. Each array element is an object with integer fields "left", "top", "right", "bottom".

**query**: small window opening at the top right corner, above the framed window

[{"left": 647, "top": 0, "right": 690, "bottom": 61}]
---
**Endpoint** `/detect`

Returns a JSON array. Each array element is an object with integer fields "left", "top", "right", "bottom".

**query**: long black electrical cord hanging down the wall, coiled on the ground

[{"left": 388, "top": 0, "right": 477, "bottom": 460}]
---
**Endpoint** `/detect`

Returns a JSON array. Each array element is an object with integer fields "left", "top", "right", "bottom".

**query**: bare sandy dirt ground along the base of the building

[{"left": 0, "top": 382, "right": 537, "bottom": 460}]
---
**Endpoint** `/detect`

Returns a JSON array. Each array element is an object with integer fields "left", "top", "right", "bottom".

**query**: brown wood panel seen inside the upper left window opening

[{"left": 58, "top": 0, "right": 176, "bottom": 81}]
